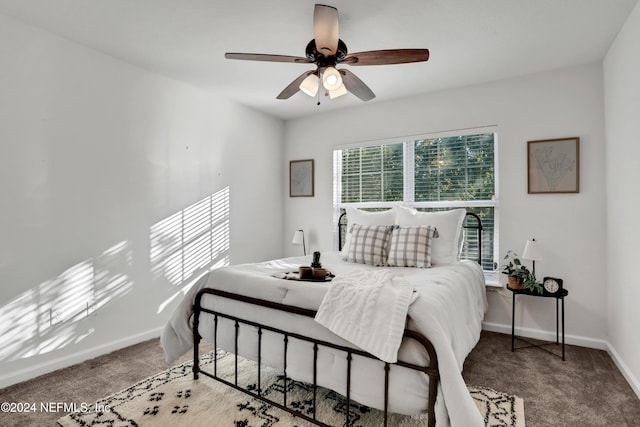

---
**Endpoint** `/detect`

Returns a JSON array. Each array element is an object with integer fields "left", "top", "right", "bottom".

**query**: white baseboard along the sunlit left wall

[{"left": 0, "top": 328, "right": 162, "bottom": 388}]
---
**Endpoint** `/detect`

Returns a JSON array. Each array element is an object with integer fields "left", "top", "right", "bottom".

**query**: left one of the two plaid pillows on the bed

[{"left": 347, "top": 224, "right": 393, "bottom": 266}]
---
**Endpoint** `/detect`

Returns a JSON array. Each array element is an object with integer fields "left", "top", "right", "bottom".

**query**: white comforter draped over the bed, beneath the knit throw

[{"left": 161, "top": 253, "right": 487, "bottom": 427}]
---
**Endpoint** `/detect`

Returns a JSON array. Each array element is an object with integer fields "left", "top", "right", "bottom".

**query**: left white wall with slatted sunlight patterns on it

[{"left": 0, "top": 15, "right": 284, "bottom": 387}]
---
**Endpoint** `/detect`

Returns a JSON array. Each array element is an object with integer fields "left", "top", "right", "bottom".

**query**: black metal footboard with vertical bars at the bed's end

[{"left": 193, "top": 288, "right": 439, "bottom": 427}]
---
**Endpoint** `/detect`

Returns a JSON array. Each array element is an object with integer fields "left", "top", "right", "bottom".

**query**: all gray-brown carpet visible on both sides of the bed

[{"left": 0, "top": 332, "right": 640, "bottom": 427}]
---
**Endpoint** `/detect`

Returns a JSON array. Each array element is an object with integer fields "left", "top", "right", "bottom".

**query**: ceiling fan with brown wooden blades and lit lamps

[{"left": 225, "top": 4, "right": 429, "bottom": 104}]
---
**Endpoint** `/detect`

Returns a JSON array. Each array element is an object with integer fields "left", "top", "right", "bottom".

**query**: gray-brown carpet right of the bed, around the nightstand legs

[{"left": 463, "top": 332, "right": 640, "bottom": 427}]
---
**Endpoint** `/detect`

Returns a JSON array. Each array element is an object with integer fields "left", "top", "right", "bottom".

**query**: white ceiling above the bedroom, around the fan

[{"left": 0, "top": 0, "right": 638, "bottom": 119}]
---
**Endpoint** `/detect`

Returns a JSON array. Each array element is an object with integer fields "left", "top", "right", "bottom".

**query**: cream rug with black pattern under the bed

[{"left": 58, "top": 351, "right": 525, "bottom": 427}]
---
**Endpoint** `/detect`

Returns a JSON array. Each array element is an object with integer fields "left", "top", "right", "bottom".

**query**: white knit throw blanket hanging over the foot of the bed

[{"left": 315, "top": 269, "right": 413, "bottom": 363}]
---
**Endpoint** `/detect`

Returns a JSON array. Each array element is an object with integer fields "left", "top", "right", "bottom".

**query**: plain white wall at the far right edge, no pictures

[{"left": 604, "top": 0, "right": 640, "bottom": 396}]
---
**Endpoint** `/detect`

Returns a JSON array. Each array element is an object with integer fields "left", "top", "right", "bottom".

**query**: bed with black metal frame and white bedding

[{"left": 161, "top": 208, "right": 487, "bottom": 427}]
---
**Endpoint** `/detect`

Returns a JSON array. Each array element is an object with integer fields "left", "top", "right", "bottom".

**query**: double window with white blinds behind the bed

[{"left": 334, "top": 128, "right": 497, "bottom": 270}]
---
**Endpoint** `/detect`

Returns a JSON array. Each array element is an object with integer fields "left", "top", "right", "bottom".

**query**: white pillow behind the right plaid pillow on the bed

[{"left": 396, "top": 206, "right": 467, "bottom": 265}]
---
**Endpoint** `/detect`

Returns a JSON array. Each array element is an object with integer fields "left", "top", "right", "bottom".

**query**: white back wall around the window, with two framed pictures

[{"left": 284, "top": 64, "right": 607, "bottom": 348}]
